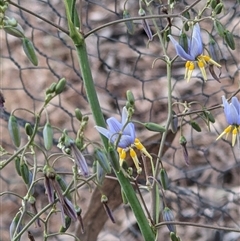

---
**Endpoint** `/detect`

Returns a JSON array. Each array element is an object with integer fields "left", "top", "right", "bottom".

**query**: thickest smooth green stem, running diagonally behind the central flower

[{"left": 64, "top": 0, "right": 155, "bottom": 241}]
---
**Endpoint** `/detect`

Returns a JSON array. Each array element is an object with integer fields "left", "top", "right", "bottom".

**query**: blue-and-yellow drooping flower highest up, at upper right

[{"left": 169, "top": 23, "right": 221, "bottom": 81}]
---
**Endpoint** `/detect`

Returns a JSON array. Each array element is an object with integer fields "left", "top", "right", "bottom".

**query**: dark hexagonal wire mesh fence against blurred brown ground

[{"left": 0, "top": 0, "right": 240, "bottom": 241}]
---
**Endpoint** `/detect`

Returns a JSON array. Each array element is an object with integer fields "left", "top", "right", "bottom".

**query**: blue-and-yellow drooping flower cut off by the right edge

[{"left": 217, "top": 96, "right": 240, "bottom": 146}]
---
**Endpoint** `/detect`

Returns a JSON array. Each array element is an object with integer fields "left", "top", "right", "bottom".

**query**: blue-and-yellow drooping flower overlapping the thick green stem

[{"left": 96, "top": 107, "right": 152, "bottom": 173}]
